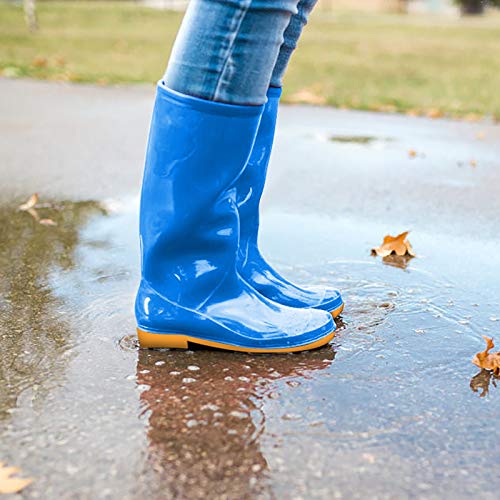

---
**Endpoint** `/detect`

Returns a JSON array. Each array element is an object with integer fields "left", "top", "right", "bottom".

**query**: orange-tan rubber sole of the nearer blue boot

[{"left": 137, "top": 328, "right": 340, "bottom": 354}]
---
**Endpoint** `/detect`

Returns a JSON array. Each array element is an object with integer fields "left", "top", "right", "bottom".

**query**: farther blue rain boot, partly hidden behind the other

[{"left": 235, "top": 87, "right": 344, "bottom": 317}]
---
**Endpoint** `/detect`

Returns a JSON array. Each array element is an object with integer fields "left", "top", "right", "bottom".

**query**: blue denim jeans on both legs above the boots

[{"left": 164, "top": 0, "right": 317, "bottom": 105}]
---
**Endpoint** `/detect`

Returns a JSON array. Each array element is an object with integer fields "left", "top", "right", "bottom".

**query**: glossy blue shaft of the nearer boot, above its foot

[{"left": 140, "top": 83, "right": 262, "bottom": 307}]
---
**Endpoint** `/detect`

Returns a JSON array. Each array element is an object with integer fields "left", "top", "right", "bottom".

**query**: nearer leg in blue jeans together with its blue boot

[{"left": 136, "top": 0, "right": 335, "bottom": 352}]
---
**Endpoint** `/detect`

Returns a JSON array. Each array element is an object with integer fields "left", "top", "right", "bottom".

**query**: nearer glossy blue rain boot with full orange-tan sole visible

[{"left": 135, "top": 83, "right": 335, "bottom": 352}]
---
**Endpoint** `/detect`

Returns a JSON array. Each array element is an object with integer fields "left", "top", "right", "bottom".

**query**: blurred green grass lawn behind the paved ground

[{"left": 0, "top": 2, "right": 500, "bottom": 120}]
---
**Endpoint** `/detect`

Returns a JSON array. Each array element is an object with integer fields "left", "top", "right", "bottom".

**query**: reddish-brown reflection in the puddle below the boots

[{"left": 137, "top": 348, "right": 335, "bottom": 498}]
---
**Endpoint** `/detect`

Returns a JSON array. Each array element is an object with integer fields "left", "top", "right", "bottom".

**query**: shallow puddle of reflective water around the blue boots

[{"left": 0, "top": 196, "right": 500, "bottom": 498}]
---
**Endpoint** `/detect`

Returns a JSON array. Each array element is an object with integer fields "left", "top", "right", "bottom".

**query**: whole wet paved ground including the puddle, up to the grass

[{"left": 0, "top": 80, "right": 500, "bottom": 499}]
